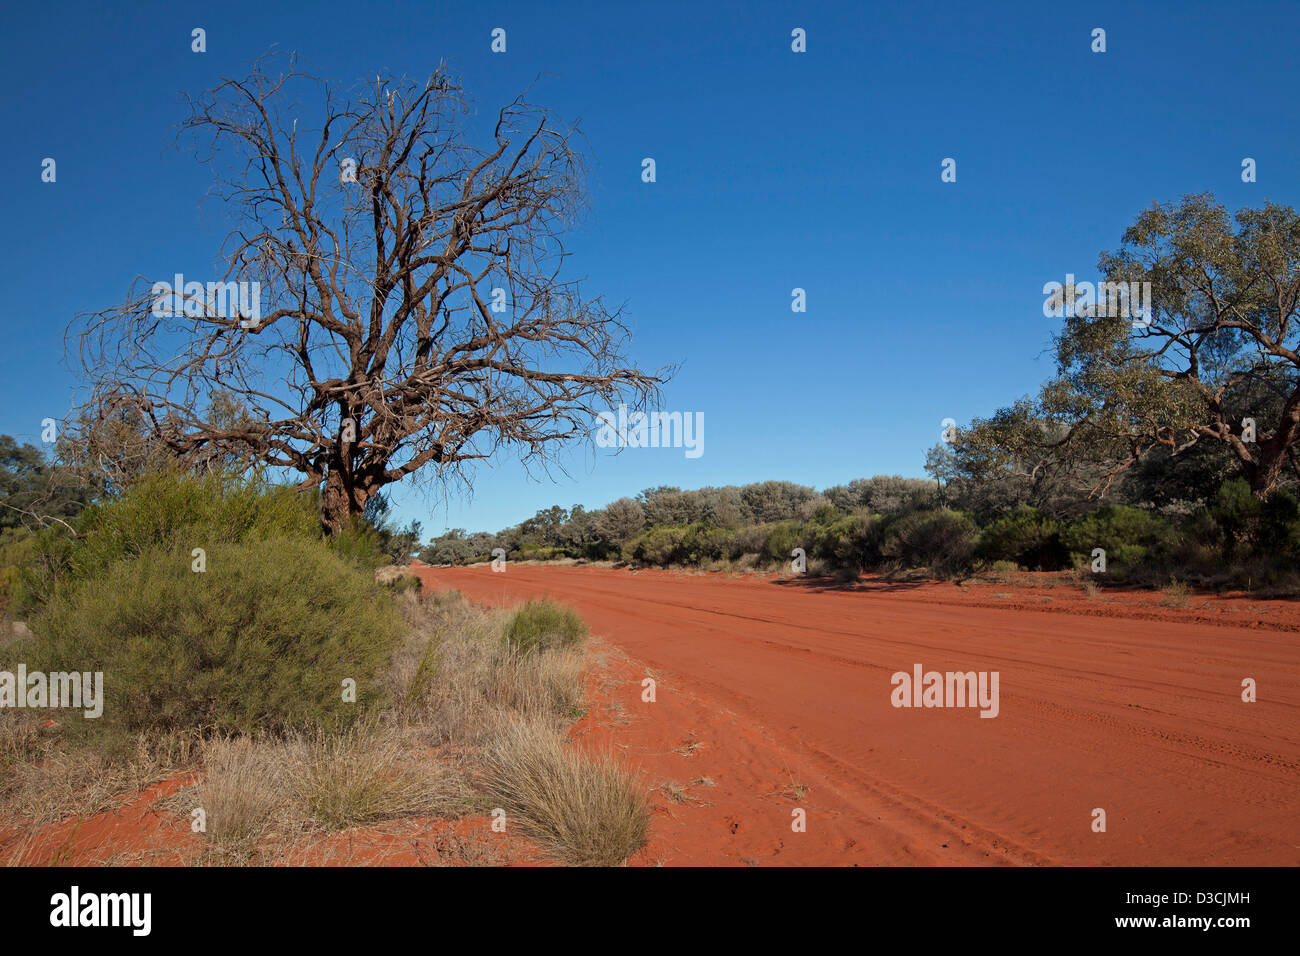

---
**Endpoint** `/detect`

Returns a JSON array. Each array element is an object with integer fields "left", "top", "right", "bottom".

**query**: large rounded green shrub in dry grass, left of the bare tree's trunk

[{"left": 19, "top": 538, "right": 402, "bottom": 732}]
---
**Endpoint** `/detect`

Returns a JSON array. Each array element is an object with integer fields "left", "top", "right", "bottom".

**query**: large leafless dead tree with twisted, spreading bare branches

[{"left": 69, "top": 60, "right": 671, "bottom": 533}]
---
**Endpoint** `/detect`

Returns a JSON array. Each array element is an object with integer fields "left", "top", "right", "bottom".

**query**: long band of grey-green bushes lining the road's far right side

[{"left": 420, "top": 473, "right": 1300, "bottom": 593}]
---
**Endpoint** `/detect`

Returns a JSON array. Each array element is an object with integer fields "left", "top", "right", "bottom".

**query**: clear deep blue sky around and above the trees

[{"left": 0, "top": 0, "right": 1300, "bottom": 535}]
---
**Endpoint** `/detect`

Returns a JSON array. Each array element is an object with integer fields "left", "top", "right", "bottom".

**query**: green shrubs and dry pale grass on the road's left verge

[{"left": 0, "top": 471, "right": 649, "bottom": 865}]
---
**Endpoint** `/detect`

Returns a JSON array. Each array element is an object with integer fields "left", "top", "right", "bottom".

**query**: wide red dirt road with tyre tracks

[{"left": 419, "top": 564, "right": 1300, "bottom": 865}]
